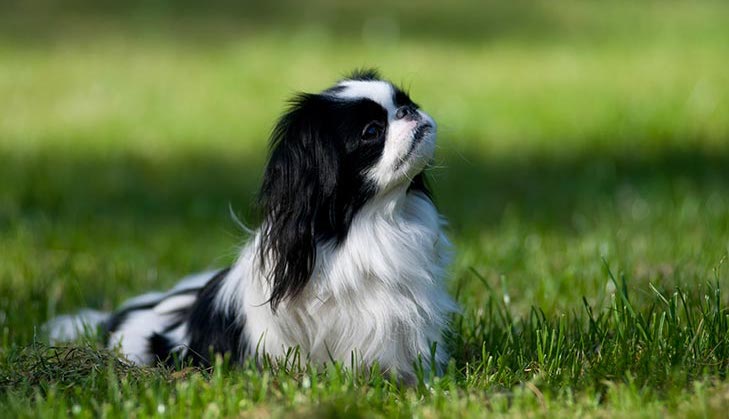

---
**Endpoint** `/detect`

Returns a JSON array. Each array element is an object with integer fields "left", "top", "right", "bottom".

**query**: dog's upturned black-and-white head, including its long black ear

[{"left": 260, "top": 71, "right": 436, "bottom": 306}]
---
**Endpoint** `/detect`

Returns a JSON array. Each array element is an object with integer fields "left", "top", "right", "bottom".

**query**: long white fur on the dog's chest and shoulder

[{"left": 222, "top": 191, "right": 455, "bottom": 375}]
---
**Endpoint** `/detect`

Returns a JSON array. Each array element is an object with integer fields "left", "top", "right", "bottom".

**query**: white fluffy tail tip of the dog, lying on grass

[{"left": 41, "top": 309, "right": 111, "bottom": 344}]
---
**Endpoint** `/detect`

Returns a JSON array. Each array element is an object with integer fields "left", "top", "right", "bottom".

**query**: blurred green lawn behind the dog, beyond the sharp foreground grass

[{"left": 0, "top": 0, "right": 729, "bottom": 347}]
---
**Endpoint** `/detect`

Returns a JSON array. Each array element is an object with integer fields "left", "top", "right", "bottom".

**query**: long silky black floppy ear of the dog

[{"left": 259, "top": 94, "right": 340, "bottom": 310}]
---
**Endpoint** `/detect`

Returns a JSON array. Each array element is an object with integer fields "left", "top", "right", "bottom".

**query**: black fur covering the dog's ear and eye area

[{"left": 260, "top": 94, "right": 387, "bottom": 310}]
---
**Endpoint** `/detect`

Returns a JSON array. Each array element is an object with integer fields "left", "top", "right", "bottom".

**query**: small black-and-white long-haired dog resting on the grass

[{"left": 47, "top": 70, "right": 456, "bottom": 380}]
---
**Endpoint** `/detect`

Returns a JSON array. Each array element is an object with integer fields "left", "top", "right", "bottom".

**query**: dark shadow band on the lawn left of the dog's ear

[{"left": 0, "top": 152, "right": 262, "bottom": 231}]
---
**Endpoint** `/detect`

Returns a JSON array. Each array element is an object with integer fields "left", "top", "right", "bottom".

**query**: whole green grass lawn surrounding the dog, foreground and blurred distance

[{"left": 0, "top": 1, "right": 729, "bottom": 417}]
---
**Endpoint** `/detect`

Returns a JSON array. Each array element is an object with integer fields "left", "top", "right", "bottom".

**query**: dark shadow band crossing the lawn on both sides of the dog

[{"left": 0, "top": 144, "right": 729, "bottom": 233}]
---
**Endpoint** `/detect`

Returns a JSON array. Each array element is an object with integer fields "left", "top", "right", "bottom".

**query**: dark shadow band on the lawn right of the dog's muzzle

[{"left": 433, "top": 148, "right": 729, "bottom": 233}]
